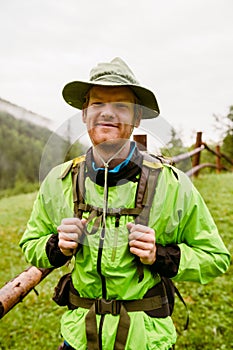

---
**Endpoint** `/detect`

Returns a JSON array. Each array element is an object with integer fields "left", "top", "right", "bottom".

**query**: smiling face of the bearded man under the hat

[{"left": 83, "top": 86, "right": 140, "bottom": 146}]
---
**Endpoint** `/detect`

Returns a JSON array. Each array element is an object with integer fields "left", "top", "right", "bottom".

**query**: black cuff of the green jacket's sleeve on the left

[{"left": 45, "top": 234, "right": 71, "bottom": 267}]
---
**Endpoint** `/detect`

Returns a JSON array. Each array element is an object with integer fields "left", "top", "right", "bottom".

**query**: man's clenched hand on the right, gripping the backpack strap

[{"left": 127, "top": 222, "right": 156, "bottom": 265}]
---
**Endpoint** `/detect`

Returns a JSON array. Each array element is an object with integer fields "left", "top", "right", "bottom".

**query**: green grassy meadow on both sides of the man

[{"left": 0, "top": 174, "right": 233, "bottom": 350}]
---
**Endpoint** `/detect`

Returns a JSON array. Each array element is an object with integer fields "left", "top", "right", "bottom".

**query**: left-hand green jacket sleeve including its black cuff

[{"left": 19, "top": 161, "right": 73, "bottom": 268}]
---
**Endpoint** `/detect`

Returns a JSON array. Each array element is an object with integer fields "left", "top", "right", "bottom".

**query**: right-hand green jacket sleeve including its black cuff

[{"left": 152, "top": 167, "right": 230, "bottom": 284}]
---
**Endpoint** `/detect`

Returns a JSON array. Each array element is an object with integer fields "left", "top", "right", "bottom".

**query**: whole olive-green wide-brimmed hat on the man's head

[{"left": 62, "top": 57, "right": 159, "bottom": 119}]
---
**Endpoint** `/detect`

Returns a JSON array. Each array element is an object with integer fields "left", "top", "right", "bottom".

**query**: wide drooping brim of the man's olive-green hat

[{"left": 62, "top": 81, "right": 160, "bottom": 119}]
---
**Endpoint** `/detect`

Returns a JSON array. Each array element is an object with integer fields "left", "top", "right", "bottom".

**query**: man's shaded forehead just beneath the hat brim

[{"left": 89, "top": 86, "right": 136, "bottom": 102}]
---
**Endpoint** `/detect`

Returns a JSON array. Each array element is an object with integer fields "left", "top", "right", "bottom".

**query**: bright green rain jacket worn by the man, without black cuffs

[{"left": 20, "top": 150, "right": 230, "bottom": 350}]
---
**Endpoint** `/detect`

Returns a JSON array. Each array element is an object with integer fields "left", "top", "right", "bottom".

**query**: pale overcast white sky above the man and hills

[{"left": 0, "top": 0, "right": 233, "bottom": 146}]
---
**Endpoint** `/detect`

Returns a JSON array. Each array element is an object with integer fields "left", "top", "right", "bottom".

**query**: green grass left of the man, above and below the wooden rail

[{"left": 0, "top": 193, "right": 68, "bottom": 350}]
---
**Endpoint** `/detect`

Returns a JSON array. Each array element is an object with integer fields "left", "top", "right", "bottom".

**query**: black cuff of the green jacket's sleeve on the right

[{"left": 151, "top": 244, "right": 180, "bottom": 278}]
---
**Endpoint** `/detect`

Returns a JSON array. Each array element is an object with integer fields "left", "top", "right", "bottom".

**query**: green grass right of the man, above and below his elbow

[{"left": 174, "top": 173, "right": 233, "bottom": 350}]
